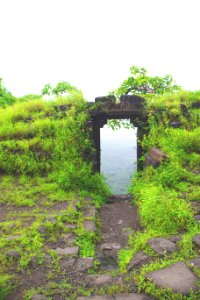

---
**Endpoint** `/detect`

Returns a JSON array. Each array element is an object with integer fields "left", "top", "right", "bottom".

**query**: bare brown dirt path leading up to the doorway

[{"left": 96, "top": 196, "right": 141, "bottom": 270}]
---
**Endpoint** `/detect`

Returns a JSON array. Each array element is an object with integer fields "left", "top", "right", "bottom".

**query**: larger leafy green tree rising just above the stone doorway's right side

[{"left": 113, "top": 66, "right": 180, "bottom": 97}]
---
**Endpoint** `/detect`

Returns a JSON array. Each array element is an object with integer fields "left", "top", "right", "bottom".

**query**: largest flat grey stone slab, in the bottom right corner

[{"left": 146, "top": 262, "right": 198, "bottom": 294}]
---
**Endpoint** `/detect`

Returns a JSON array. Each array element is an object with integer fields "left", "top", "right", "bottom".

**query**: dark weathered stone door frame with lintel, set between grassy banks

[{"left": 87, "top": 95, "right": 148, "bottom": 172}]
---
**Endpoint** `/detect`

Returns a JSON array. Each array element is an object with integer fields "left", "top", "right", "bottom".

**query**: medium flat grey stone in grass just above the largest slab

[{"left": 148, "top": 238, "right": 178, "bottom": 255}]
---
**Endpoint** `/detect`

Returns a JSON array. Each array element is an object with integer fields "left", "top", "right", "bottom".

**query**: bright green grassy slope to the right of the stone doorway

[{"left": 120, "top": 91, "right": 200, "bottom": 299}]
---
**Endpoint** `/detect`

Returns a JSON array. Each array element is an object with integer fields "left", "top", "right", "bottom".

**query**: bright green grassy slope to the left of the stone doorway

[{"left": 0, "top": 94, "right": 108, "bottom": 299}]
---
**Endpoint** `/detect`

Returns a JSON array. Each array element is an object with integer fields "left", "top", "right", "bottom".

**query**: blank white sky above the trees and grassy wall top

[{"left": 0, "top": 0, "right": 200, "bottom": 101}]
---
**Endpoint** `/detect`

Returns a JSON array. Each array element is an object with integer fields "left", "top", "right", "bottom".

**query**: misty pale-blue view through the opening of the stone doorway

[{"left": 100, "top": 120, "right": 137, "bottom": 195}]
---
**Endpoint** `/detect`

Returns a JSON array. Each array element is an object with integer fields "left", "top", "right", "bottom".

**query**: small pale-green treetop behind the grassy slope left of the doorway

[{"left": 42, "top": 81, "right": 80, "bottom": 96}]
